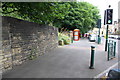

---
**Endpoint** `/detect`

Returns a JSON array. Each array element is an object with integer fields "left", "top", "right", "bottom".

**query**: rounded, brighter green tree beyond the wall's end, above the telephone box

[{"left": 55, "top": 2, "right": 100, "bottom": 33}]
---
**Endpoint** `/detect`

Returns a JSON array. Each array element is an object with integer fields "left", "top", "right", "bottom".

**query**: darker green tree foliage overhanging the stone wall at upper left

[{"left": 2, "top": 2, "right": 69, "bottom": 24}]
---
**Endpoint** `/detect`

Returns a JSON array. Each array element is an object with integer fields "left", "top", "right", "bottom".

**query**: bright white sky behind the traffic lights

[{"left": 77, "top": 0, "right": 120, "bottom": 23}]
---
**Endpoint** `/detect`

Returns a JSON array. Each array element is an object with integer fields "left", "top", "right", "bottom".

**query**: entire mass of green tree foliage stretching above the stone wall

[{"left": 2, "top": 2, "right": 100, "bottom": 33}]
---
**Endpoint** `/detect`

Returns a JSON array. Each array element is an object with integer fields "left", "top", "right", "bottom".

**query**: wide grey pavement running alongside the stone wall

[{"left": 2, "top": 39, "right": 118, "bottom": 78}]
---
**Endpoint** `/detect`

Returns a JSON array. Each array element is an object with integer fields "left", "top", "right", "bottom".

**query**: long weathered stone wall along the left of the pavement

[{"left": 2, "top": 16, "right": 58, "bottom": 72}]
